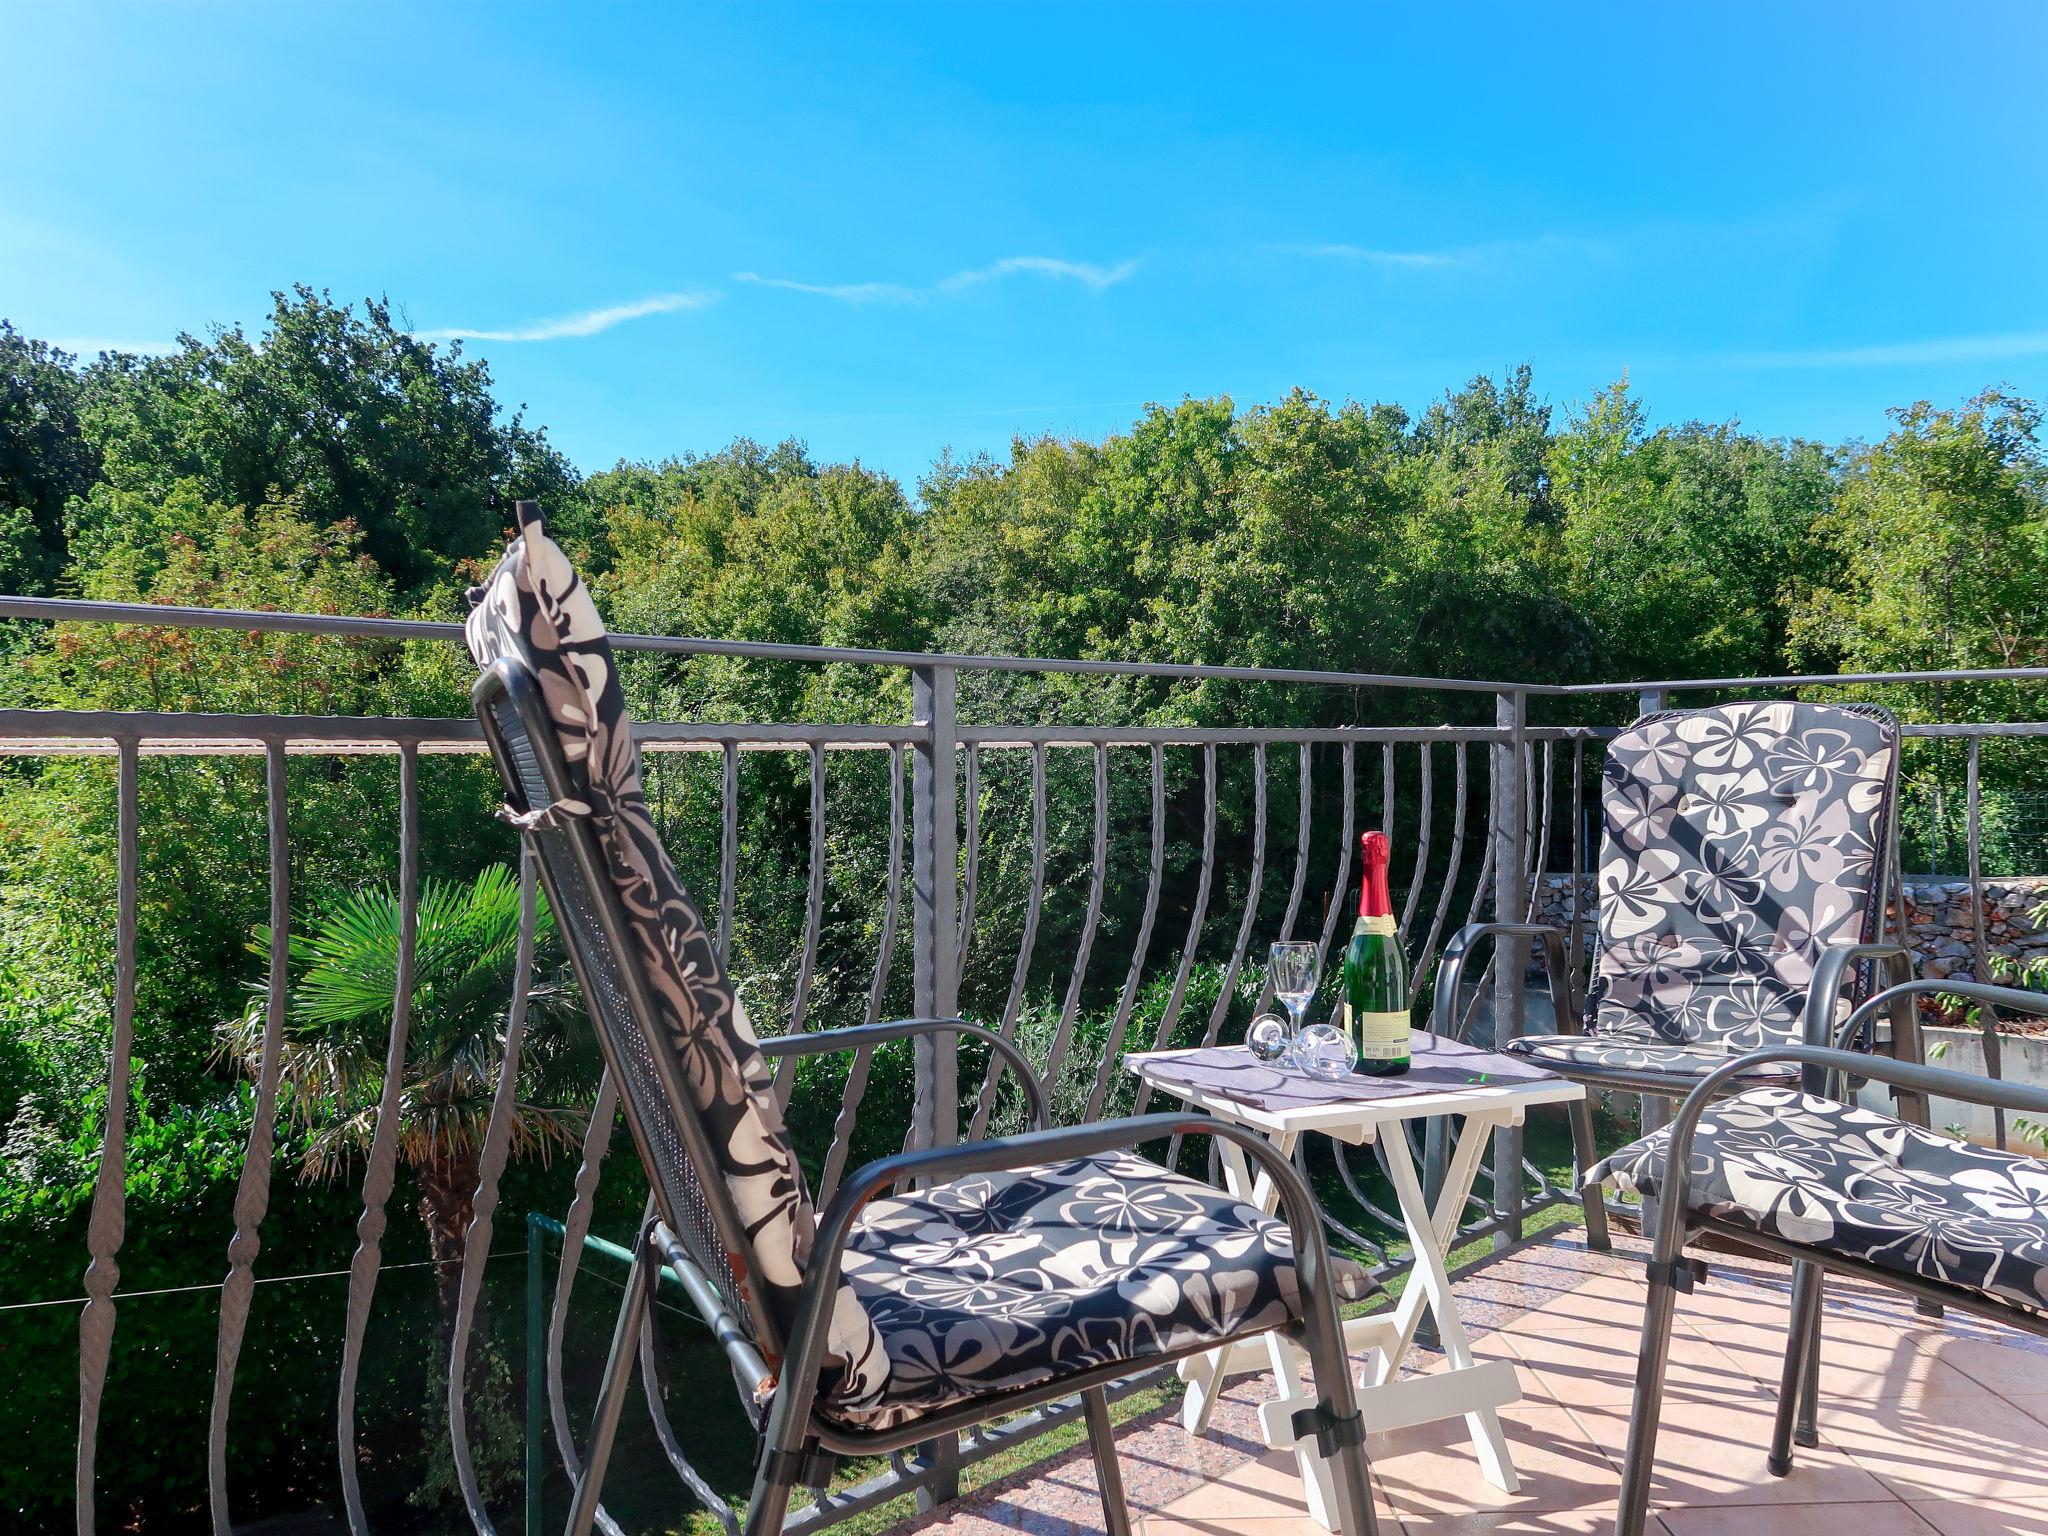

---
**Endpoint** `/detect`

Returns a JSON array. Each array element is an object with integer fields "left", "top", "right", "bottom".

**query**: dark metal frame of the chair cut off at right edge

[{"left": 1616, "top": 979, "right": 2048, "bottom": 1536}]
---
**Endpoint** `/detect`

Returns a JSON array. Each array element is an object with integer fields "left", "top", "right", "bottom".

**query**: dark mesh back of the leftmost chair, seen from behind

[{"left": 492, "top": 696, "right": 754, "bottom": 1331}]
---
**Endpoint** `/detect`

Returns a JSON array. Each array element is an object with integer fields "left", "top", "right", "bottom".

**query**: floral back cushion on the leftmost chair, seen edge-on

[{"left": 465, "top": 502, "right": 887, "bottom": 1401}]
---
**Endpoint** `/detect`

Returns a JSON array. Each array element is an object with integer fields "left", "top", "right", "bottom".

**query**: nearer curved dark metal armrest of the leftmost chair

[{"left": 778, "top": 1110, "right": 1329, "bottom": 1413}]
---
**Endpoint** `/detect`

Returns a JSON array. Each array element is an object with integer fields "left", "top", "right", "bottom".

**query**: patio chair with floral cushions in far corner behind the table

[{"left": 1434, "top": 702, "right": 1917, "bottom": 1247}]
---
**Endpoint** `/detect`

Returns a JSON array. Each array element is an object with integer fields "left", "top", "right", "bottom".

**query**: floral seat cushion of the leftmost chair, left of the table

[{"left": 823, "top": 1153, "right": 1376, "bottom": 1430}]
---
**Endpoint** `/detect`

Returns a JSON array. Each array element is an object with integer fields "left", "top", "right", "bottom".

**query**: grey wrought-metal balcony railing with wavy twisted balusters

[{"left": 0, "top": 598, "right": 2048, "bottom": 1536}]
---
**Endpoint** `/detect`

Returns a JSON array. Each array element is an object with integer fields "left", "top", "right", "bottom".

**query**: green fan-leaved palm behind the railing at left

[{"left": 221, "top": 864, "right": 598, "bottom": 1329}]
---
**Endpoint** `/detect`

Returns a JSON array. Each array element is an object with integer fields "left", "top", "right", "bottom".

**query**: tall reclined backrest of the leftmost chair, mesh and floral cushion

[{"left": 465, "top": 502, "right": 872, "bottom": 1393}]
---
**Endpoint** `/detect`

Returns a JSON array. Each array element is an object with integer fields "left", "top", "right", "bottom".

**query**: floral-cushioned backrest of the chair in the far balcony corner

[{"left": 1585, "top": 702, "right": 1898, "bottom": 1051}]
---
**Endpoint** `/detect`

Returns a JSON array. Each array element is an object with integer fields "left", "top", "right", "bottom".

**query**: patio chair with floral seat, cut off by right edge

[{"left": 1589, "top": 979, "right": 2048, "bottom": 1536}]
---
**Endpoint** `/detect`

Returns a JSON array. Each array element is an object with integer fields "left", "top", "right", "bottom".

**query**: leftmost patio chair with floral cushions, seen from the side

[{"left": 467, "top": 502, "right": 1376, "bottom": 1536}]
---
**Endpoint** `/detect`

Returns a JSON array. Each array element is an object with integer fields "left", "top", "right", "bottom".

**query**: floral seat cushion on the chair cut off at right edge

[{"left": 1587, "top": 1087, "right": 2048, "bottom": 1309}]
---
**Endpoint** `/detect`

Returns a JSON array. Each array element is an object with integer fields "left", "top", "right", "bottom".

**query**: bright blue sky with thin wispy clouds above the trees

[{"left": 0, "top": 0, "right": 2048, "bottom": 479}]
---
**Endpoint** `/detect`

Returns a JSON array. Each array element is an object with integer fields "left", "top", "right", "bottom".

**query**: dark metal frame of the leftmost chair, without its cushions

[{"left": 471, "top": 657, "right": 1378, "bottom": 1536}]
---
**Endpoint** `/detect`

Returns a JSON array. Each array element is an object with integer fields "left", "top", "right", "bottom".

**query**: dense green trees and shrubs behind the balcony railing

[{"left": 0, "top": 289, "right": 2048, "bottom": 1524}]
